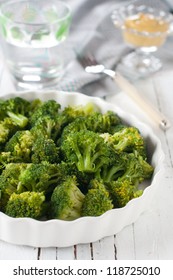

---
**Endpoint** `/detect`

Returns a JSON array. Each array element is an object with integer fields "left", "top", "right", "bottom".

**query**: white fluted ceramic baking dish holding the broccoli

[{"left": 0, "top": 91, "right": 164, "bottom": 247}]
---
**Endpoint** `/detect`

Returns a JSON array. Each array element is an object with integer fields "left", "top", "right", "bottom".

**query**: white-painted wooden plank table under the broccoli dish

[{"left": 0, "top": 57, "right": 173, "bottom": 260}]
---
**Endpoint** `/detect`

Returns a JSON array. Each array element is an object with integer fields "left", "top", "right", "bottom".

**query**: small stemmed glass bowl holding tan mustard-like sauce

[{"left": 111, "top": 4, "right": 173, "bottom": 77}]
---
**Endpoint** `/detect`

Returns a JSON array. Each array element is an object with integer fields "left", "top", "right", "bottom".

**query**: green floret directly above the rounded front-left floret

[{"left": 19, "top": 162, "right": 64, "bottom": 193}]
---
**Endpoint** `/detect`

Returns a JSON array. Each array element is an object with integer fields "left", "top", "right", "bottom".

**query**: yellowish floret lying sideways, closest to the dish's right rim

[{"left": 101, "top": 127, "right": 146, "bottom": 158}]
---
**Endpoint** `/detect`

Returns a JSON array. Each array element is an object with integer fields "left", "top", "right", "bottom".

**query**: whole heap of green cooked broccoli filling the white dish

[{"left": 0, "top": 97, "right": 153, "bottom": 220}]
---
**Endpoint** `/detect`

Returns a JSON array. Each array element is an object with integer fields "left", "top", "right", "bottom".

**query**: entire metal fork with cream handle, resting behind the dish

[{"left": 77, "top": 54, "right": 170, "bottom": 130}]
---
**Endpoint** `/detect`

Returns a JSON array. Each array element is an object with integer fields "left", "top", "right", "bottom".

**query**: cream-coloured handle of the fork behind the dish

[{"left": 112, "top": 72, "right": 171, "bottom": 130}]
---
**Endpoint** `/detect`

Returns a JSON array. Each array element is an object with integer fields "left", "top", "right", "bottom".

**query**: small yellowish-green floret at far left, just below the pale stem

[{"left": 5, "top": 130, "right": 34, "bottom": 162}]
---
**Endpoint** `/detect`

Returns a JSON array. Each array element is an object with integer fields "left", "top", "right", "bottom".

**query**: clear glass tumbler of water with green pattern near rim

[{"left": 0, "top": 0, "right": 71, "bottom": 89}]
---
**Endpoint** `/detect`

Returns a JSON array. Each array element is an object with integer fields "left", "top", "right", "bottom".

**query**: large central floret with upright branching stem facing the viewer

[{"left": 60, "top": 130, "right": 110, "bottom": 172}]
